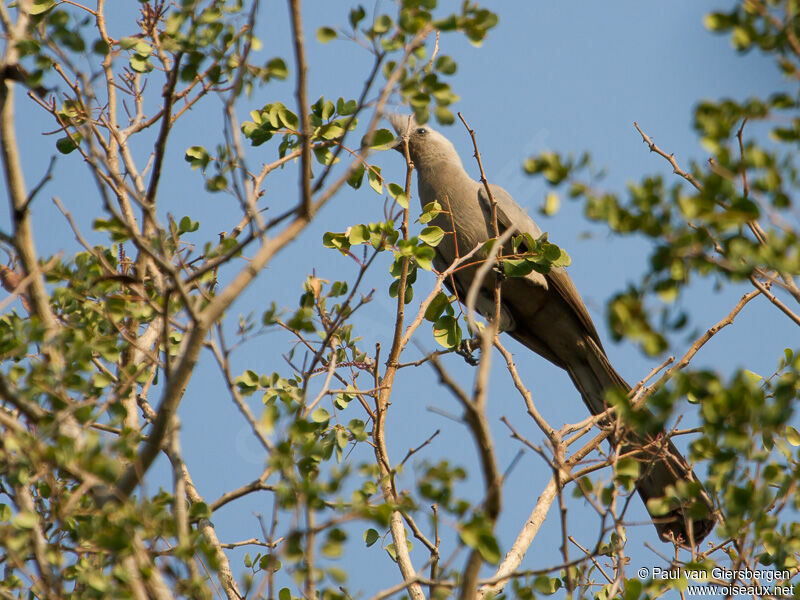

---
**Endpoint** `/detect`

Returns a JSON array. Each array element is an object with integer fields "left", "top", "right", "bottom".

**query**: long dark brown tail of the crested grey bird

[{"left": 567, "top": 342, "right": 714, "bottom": 545}]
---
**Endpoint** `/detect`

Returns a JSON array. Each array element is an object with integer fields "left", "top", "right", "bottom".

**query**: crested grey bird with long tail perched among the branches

[{"left": 387, "top": 114, "right": 714, "bottom": 544}]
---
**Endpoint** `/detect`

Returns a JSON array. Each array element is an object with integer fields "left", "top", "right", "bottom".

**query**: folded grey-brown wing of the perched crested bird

[{"left": 478, "top": 184, "right": 603, "bottom": 350}]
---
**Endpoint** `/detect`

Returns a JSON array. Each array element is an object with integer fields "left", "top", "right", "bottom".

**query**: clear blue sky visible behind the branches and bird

[{"left": 0, "top": 0, "right": 796, "bottom": 595}]
